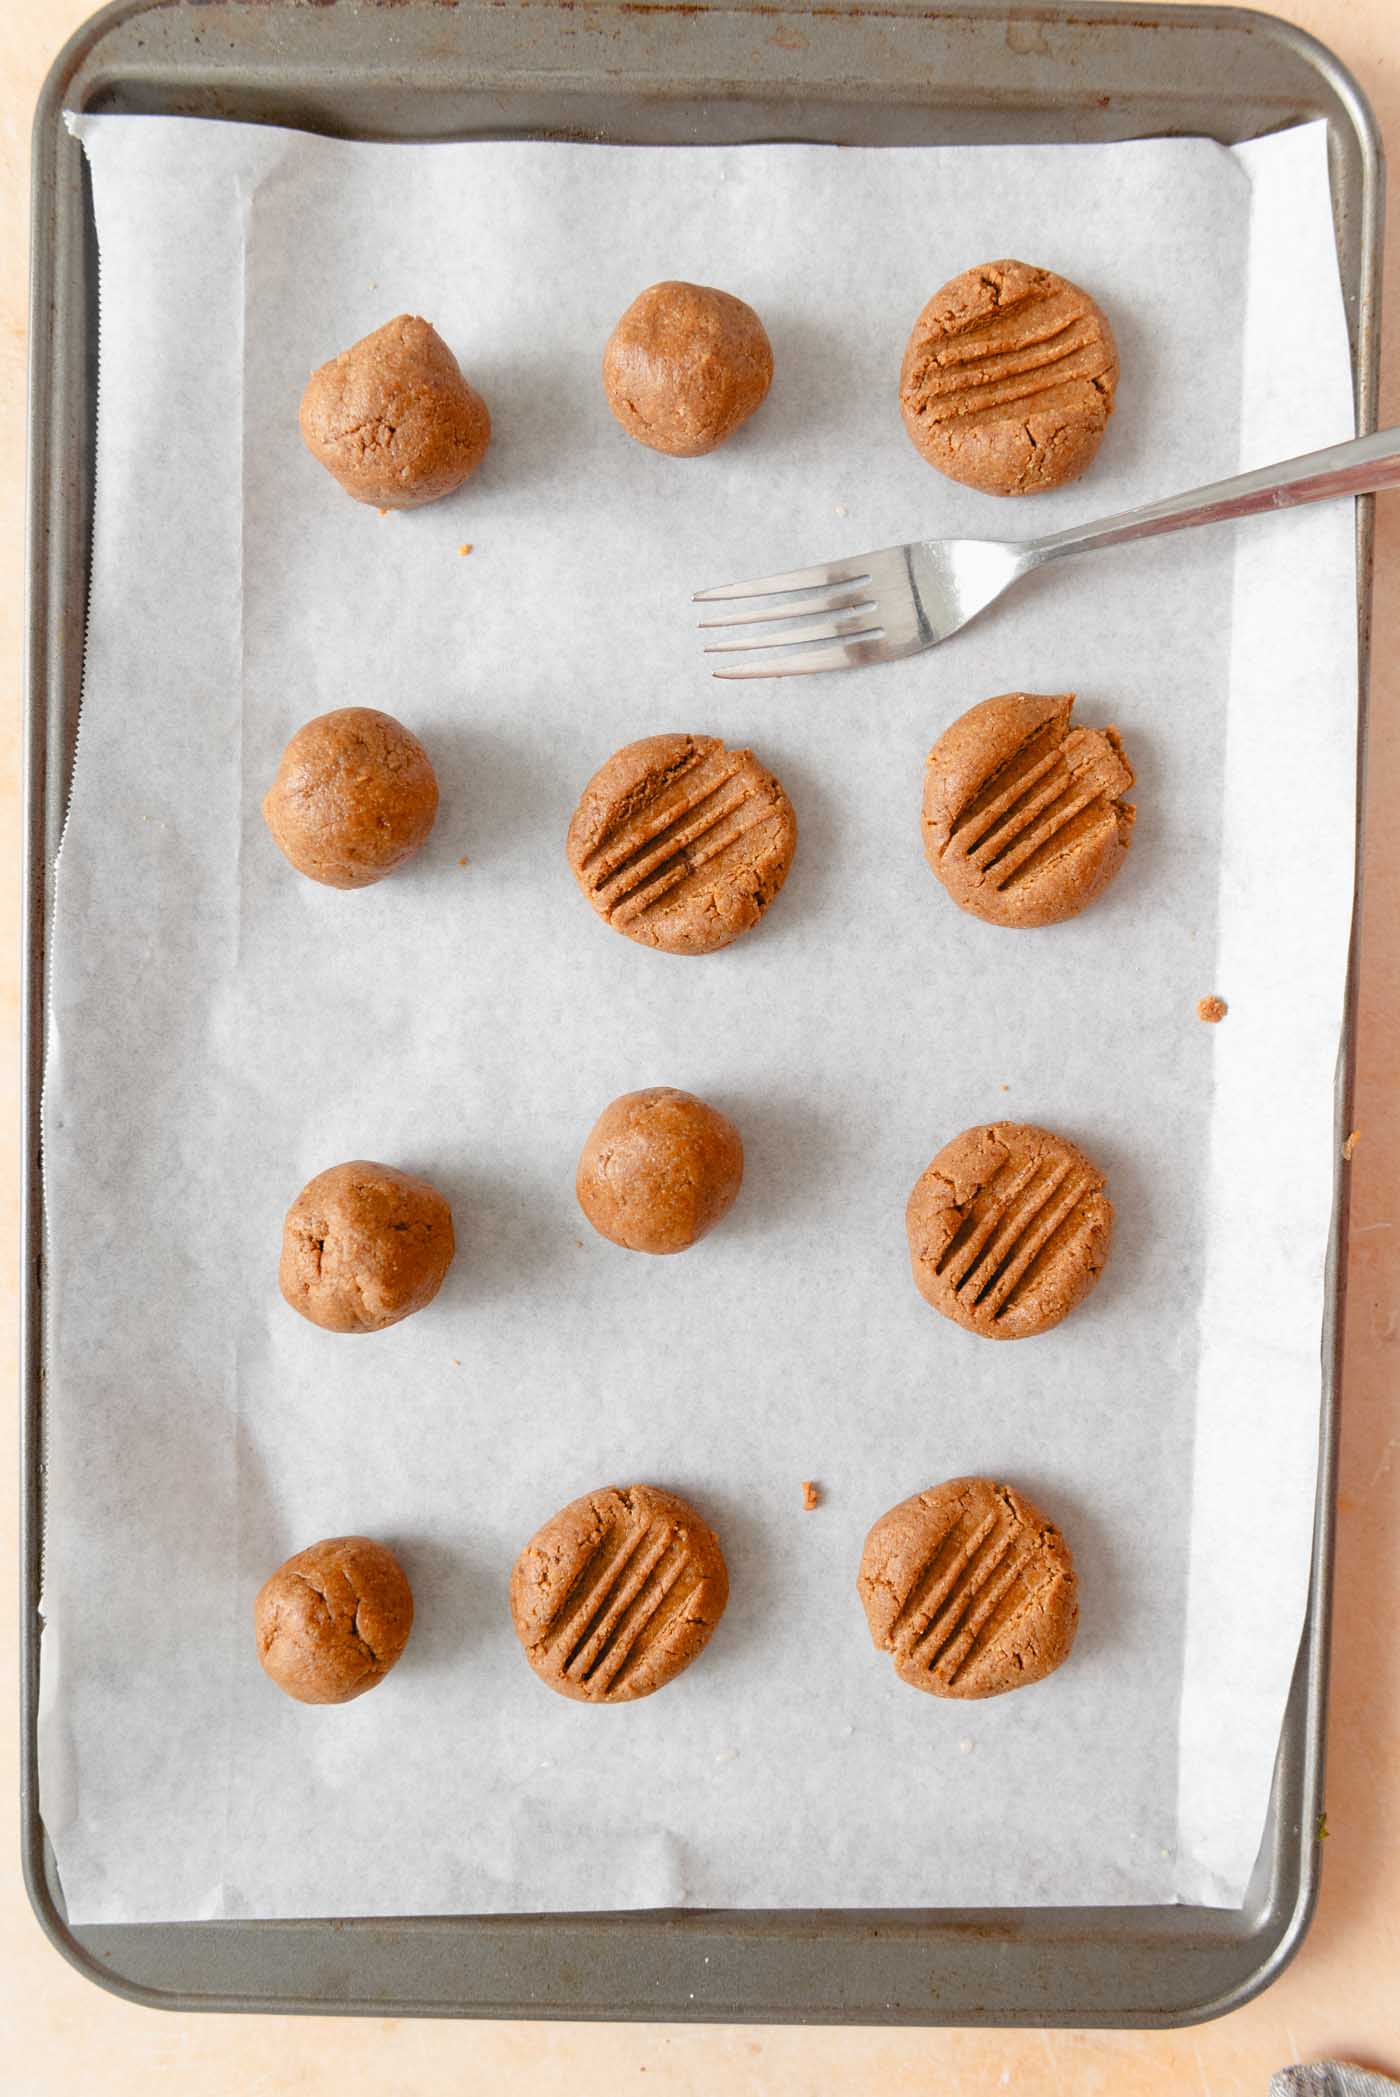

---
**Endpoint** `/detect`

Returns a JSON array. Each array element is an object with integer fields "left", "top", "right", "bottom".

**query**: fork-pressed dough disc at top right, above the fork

[{"left": 899, "top": 262, "right": 1117, "bottom": 495}]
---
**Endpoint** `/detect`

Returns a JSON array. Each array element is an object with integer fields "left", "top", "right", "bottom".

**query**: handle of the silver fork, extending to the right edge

[{"left": 1025, "top": 430, "right": 1400, "bottom": 564}]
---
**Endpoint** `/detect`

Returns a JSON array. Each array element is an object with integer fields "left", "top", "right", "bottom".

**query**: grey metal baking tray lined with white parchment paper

[{"left": 21, "top": 0, "right": 1383, "bottom": 2026}]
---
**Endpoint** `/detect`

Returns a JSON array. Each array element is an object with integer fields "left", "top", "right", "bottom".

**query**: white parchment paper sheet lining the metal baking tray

[{"left": 42, "top": 117, "right": 1354, "bottom": 1921}]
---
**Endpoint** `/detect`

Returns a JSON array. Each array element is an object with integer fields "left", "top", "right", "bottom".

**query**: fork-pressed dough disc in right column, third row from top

[{"left": 905, "top": 1122, "right": 1113, "bottom": 1340}]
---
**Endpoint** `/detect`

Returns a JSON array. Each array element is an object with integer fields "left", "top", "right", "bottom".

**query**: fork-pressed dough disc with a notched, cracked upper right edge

[{"left": 922, "top": 692, "right": 1138, "bottom": 925}]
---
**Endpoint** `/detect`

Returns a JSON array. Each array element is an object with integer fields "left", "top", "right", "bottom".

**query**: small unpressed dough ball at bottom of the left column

[{"left": 254, "top": 1537, "right": 413, "bottom": 1703}]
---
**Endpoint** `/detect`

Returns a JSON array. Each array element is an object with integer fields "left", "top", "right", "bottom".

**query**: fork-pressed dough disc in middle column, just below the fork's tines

[{"left": 568, "top": 736, "right": 796, "bottom": 954}]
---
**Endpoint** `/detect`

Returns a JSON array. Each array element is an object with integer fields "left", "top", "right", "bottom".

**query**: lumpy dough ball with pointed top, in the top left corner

[{"left": 302, "top": 312, "right": 490, "bottom": 510}]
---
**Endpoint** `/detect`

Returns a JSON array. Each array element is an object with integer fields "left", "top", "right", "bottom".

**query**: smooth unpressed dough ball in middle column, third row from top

[{"left": 574, "top": 1084, "right": 744, "bottom": 1252}]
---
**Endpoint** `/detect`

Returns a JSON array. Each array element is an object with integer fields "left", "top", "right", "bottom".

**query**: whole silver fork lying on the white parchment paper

[{"left": 694, "top": 430, "right": 1400, "bottom": 677}]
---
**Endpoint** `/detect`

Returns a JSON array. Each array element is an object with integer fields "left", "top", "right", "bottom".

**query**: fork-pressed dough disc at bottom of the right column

[{"left": 855, "top": 1478, "right": 1079, "bottom": 1696}]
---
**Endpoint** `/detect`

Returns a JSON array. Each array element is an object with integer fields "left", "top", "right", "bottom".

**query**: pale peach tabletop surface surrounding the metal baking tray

[{"left": 0, "top": 0, "right": 1400, "bottom": 2097}]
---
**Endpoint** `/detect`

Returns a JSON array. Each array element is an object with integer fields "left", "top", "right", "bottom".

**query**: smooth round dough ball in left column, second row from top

[{"left": 262, "top": 707, "right": 438, "bottom": 889}]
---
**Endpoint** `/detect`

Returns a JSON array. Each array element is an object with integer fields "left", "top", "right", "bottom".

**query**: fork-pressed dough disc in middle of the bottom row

[{"left": 511, "top": 1485, "right": 729, "bottom": 1703}]
